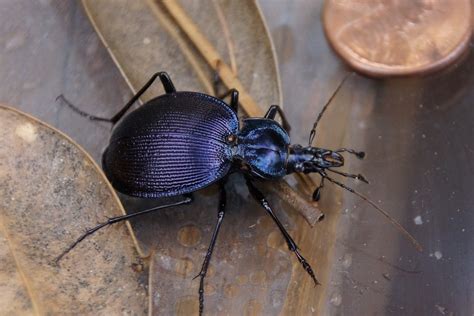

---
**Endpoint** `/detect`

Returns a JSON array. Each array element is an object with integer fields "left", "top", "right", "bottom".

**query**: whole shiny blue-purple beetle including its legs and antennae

[{"left": 57, "top": 72, "right": 422, "bottom": 314}]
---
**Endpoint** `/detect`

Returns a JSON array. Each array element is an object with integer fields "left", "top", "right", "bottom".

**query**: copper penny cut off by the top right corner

[{"left": 323, "top": 0, "right": 472, "bottom": 77}]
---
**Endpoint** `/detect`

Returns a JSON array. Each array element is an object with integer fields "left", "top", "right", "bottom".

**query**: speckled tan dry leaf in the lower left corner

[{"left": 0, "top": 106, "right": 148, "bottom": 315}]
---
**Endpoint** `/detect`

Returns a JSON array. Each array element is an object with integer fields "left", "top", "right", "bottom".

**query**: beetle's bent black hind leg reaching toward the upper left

[{"left": 56, "top": 72, "right": 176, "bottom": 124}]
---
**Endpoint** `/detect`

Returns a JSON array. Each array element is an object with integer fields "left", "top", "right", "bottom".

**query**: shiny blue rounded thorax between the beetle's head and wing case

[{"left": 234, "top": 118, "right": 290, "bottom": 179}]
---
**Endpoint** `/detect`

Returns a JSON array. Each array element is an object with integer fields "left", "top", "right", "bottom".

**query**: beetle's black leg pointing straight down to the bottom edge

[{"left": 194, "top": 180, "right": 226, "bottom": 315}]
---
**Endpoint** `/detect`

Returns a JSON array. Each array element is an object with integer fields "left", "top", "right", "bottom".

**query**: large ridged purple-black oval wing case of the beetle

[{"left": 102, "top": 92, "right": 239, "bottom": 198}]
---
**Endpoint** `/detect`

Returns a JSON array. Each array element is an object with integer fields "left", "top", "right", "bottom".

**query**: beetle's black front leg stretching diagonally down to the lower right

[{"left": 246, "top": 177, "right": 320, "bottom": 285}]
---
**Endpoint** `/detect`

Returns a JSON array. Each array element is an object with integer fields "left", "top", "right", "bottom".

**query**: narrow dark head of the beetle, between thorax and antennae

[{"left": 287, "top": 145, "right": 344, "bottom": 173}]
